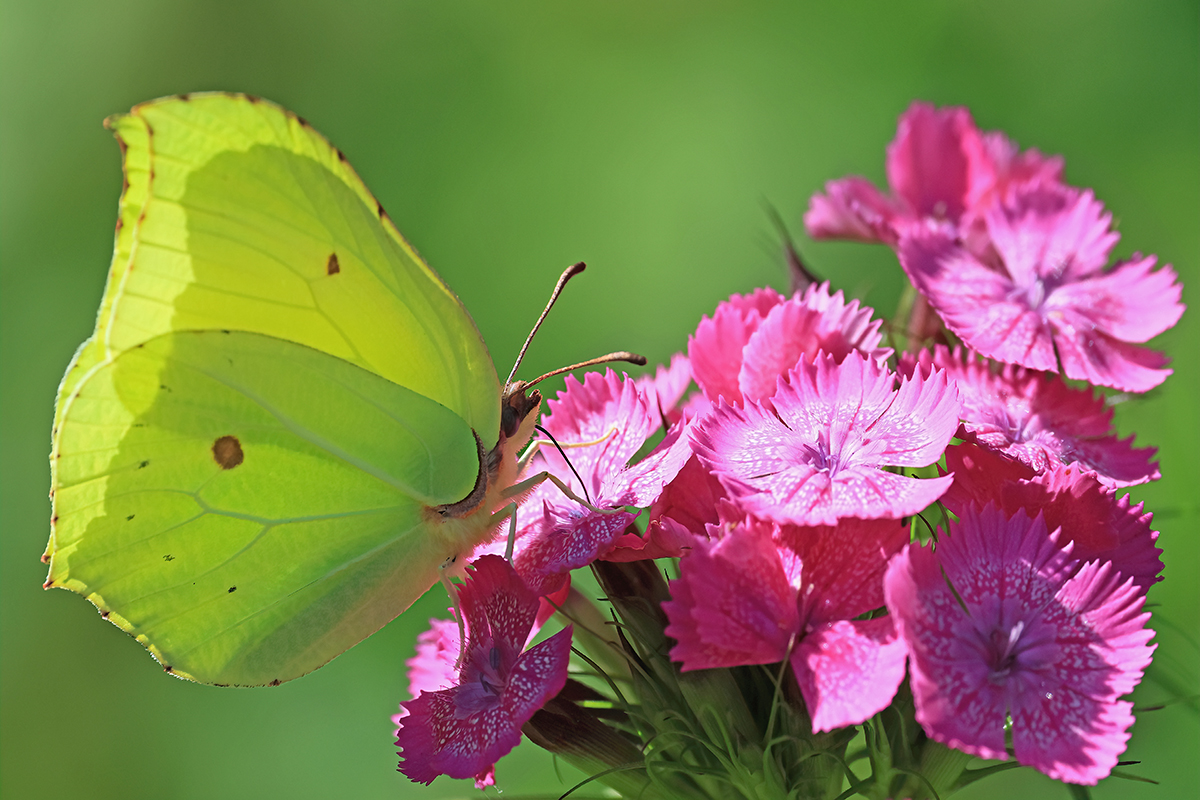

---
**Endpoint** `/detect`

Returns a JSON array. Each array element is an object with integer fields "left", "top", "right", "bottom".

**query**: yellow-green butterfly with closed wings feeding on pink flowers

[{"left": 43, "top": 94, "right": 576, "bottom": 686}]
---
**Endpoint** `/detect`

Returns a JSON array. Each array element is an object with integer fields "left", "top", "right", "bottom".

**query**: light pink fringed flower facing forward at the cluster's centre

[{"left": 692, "top": 353, "right": 959, "bottom": 525}]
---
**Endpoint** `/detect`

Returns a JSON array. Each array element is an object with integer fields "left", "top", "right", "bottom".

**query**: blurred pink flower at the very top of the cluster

[{"left": 804, "top": 103, "right": 1062, "bottom": 245}]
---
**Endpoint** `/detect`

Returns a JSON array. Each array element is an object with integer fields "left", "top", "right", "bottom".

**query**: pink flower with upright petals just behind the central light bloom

[{"left": 688, "top": 283, "right": 892, "bottom": 405}]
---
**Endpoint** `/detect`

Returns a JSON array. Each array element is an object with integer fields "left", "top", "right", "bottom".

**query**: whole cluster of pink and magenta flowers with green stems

[{"left": 396, "top": 103, "right": 1183, "bottom": 798}]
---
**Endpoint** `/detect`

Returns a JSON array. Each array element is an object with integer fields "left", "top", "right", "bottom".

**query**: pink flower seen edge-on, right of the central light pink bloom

[{"left": 900, "top": 345, "right": 1160, "bottom": 486}]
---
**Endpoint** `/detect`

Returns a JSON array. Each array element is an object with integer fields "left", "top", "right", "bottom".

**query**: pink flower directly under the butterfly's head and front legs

[{"left": 486, "top": 371, "right": 691, "bottom": 595}]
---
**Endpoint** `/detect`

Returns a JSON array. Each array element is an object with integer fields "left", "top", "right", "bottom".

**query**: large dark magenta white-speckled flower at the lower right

[{"left": 884, "top": 506, "right": 1154, "bottom": 783}]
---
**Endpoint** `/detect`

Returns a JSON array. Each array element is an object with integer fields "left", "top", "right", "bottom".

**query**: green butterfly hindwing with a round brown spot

[{"left": 49, "top": 331, "right": 479, "bottom": 685}]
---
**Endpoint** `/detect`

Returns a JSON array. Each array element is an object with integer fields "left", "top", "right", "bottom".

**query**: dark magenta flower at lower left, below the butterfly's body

[{"left": 396, "top": 555, "right": 571, "bottom": 786}]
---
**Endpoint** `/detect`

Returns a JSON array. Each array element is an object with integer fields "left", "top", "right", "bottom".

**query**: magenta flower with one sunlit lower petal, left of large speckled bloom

[{"left": 662, "top": 519, "right": 908, "bottom": 733}]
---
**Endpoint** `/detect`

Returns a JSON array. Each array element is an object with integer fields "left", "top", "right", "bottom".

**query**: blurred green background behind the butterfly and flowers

[{"left": 0, "top": 0, "right": 1200, "bottom": 800}]
